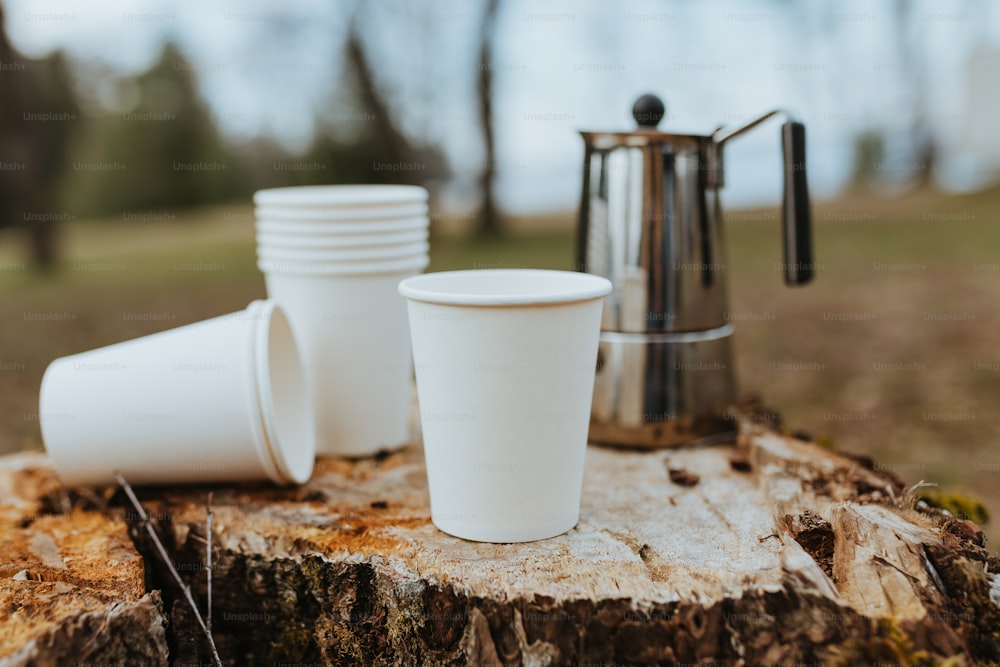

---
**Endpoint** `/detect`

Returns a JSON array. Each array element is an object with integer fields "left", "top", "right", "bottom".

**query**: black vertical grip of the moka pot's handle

[{"left": 781, "top": 121, "right": 816, "bottom": 286}]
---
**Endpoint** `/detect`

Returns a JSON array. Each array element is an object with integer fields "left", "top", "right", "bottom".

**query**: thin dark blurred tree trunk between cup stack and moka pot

[{"left": 478, "top": 0, "right": 501, "bottom": 236}]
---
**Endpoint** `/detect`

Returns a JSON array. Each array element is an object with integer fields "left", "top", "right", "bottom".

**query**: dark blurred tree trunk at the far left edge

[{"left": 0, "top": 5, "right": 56, "bottom": 269}]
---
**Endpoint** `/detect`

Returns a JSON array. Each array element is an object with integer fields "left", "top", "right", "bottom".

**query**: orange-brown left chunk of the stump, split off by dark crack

[{"left": 0, "top": 454, "right": 167, "bottom": 667}]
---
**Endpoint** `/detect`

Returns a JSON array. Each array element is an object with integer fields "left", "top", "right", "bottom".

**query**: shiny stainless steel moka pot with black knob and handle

[{"left": 577, "top": 95, "right": 814, "bottom": 447}]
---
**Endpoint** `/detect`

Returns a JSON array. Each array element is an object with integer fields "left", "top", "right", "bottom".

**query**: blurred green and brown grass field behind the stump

[{"left": 0, "top": 191, "right": 1000, "bottom": 537}]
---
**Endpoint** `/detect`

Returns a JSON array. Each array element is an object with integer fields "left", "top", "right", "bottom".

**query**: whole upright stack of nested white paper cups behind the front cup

[{"left": 254, "top": 185, "right": 428, "bottom": 456}]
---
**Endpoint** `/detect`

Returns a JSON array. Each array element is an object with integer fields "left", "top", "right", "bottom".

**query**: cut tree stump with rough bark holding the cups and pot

[{"left": 0, "top": 421, "right": 1000, "bottom": 665}]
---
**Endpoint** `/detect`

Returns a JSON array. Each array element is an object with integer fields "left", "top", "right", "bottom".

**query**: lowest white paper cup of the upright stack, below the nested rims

[{"left": 265, "top": 266, "right": 423, "bottom": 456}]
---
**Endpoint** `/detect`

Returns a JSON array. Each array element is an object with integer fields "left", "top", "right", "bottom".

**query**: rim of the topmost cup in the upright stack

[{"left": 253, "top": 185, "right": 427, "bottom": 209}]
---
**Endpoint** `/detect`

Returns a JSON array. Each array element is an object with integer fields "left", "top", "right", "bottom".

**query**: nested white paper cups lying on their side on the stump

[{"left": 39, "top": 301, "right": 315, "bottom": 485}]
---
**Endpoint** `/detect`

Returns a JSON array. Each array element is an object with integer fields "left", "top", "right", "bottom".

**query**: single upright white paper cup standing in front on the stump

[{"left": 399, "top": 269, "right": 611, "bottom": 542}]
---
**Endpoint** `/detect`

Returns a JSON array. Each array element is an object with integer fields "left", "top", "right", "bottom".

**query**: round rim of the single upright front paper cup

[{"left": 399, "top": 269, "right": 612, "bottom": 307}]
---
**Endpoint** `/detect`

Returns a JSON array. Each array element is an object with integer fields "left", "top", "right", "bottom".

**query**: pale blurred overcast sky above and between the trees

[{"left": 3, "top": 0, "right": 1000, "bottom": 210}]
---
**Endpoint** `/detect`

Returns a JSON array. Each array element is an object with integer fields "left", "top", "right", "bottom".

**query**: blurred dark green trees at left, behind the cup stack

[{"left": 0, "top": 6, "right": 449, "bottom": 269}]
